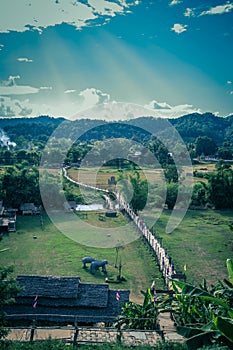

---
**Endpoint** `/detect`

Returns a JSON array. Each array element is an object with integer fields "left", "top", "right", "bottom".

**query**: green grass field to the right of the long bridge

[{"left": 143, "top": 210, "right": 233, "bottom": 284}]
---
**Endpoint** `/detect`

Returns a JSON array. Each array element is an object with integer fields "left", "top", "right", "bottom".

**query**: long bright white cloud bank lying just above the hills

[{"left": 0, "top": 87, "right": 202, "bottom": 120}]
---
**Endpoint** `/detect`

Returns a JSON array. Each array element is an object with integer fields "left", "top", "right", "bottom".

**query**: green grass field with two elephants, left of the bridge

[{"left": 0, "top": 214, "right": 163, "bottom": 301}]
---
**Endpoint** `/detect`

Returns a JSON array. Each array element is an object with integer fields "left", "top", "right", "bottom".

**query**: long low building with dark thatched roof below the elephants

[{"left": 4, "top": 275, "right": 130, "bottom": 325}]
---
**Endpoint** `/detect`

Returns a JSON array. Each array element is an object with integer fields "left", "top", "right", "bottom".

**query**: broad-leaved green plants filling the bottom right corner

[{"left": 171, "top": 259, "right": 233, "bottom": 349}]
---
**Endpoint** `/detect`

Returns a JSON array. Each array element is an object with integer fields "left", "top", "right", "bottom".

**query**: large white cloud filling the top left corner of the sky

[{"left": 0, "top": 0, "right": 139, "bottom": 33}]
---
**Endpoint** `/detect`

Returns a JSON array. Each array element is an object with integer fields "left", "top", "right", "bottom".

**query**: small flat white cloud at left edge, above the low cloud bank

[{"left": 0, "top": 75, "right": 39, "bottom": 96}]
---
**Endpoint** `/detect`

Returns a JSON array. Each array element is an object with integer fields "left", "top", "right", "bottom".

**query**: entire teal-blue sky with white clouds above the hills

[{"left": 0, "top": 0, "right": 233, "bottom": 120}]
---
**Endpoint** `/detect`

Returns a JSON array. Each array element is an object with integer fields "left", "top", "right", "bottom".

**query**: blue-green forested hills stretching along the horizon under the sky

[{"left": 0, "top": 113, "right": 233, "bottom": 145}]
